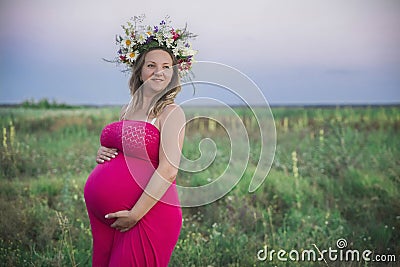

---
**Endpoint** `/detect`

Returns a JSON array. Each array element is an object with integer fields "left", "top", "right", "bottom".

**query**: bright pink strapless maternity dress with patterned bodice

[{"left": 84, "top": 120, "right": 182, "bottom": 267}]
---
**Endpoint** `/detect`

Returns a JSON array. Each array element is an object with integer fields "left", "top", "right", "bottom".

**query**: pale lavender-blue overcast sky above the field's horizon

[{"left": 0, "top": 0, "right": 400, "bottom": 104}]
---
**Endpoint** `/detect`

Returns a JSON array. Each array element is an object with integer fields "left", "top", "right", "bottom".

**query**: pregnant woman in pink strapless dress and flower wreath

[{"left": 84, "top": 17, "right": 195, "bottom": 267}]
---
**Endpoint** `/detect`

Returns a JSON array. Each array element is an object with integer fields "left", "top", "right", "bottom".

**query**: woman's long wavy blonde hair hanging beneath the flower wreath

[{"left": 121, "top": 47, "right": 181, "bottom": 119}]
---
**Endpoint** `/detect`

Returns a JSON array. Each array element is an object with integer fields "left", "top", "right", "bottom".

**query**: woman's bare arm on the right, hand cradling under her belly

[{"left": 106, "top": 105, "right": 186, "bottom": 232}]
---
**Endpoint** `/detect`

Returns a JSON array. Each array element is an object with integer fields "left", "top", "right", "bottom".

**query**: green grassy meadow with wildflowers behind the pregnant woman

[{"left": 0, "top": 106, "right": 400, "bottom": 267}]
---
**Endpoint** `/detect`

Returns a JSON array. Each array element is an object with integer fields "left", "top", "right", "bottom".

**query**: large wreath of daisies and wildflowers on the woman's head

[{"left": 116, "top": 15, "right": 197, "bottom": 78}]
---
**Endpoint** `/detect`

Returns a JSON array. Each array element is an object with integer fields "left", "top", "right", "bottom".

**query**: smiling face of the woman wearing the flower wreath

[{"left": 140, "top": 49, "right": 173, "bottom": 92}]
